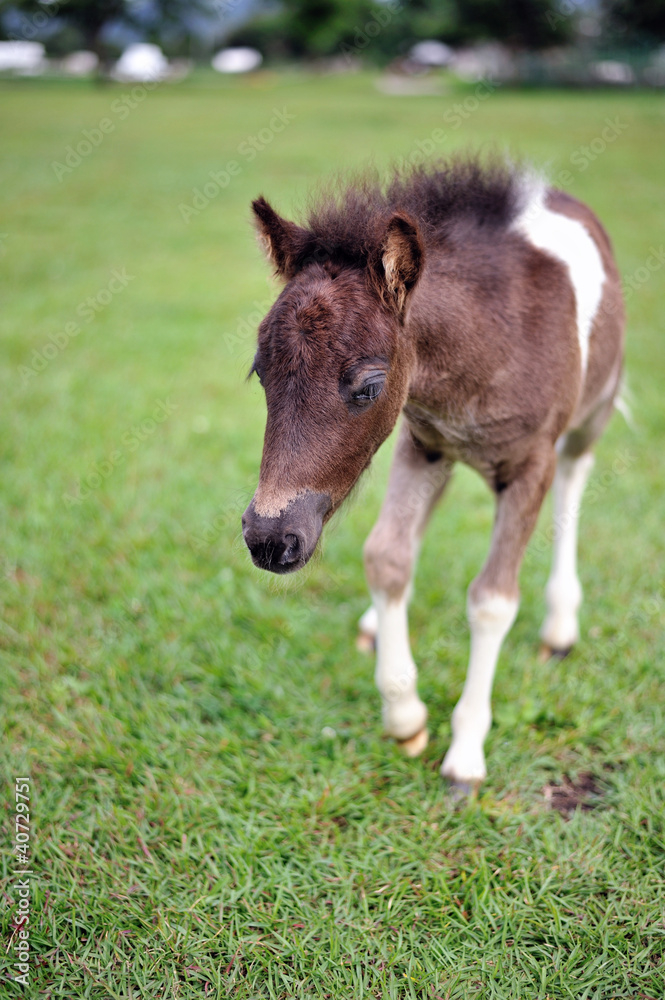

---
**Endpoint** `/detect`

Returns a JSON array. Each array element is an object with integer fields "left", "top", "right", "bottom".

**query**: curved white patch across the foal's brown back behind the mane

[{"left": 515, "top": 184, "right": 606, "bottom": 375}]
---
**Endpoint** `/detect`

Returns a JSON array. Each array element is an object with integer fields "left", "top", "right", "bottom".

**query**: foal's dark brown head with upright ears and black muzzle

[{"left": 242, "top": 198, "right": 423, "bottom": 573}]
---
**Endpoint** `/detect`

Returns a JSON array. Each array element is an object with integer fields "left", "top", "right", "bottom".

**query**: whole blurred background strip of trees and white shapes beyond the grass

[{"left": 0, "top": 0, "right": 665, "bottom": 86}]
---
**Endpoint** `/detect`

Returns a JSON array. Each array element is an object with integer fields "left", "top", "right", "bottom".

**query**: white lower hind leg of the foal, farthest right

[{"left": 540, "top": 452, "right": 593, "bottom": 652}]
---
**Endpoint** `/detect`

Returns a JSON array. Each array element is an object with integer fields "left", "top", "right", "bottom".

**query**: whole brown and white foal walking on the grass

[{"left": 243, "top": 160, "right": 624, "bottom": 787}]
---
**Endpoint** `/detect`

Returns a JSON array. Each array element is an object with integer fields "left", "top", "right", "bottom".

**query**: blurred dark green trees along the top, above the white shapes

[{"left": 0, "top": 0, "right": 665, "bottom": 62}]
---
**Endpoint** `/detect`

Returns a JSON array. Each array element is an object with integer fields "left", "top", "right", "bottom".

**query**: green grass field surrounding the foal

[{"left": 0, "top": 73, "right": 665, "bottom": 1000}]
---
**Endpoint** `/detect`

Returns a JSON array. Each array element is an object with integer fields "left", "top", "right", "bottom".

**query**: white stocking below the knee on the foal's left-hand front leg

[{"left": 372, "top": 593, "right": 427, "bottom": 740}]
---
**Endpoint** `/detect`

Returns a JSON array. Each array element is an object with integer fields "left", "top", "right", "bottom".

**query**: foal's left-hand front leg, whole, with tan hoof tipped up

[{"left": 361, "top": 424, "right": 450, "bottom": 756}]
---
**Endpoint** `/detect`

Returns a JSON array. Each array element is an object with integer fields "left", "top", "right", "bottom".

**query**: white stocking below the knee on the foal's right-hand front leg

[{"left": 441, "top": 594, "right": 519, "bottom": 784}]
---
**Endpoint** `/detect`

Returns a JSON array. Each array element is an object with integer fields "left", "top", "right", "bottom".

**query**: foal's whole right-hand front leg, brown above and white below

[{"left": 441, "top": 452, "right": 555, "bottom": 791}]
